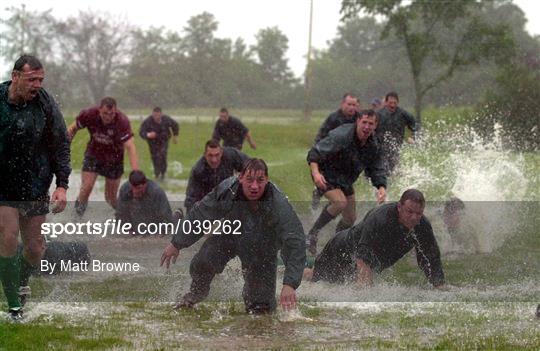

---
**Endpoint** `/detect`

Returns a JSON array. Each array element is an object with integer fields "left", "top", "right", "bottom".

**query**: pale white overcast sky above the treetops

[{"left": 0, "top": 0, "right": 540, "bottom": 76}]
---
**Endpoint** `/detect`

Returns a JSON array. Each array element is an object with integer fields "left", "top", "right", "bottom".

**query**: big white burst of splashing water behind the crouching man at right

[{"left": 390, "top": 128, "right": 537, "bottom": 253}]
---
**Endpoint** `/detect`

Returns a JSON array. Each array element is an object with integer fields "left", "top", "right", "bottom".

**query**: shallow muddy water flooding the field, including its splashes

[{"left": 17, "top": 129, "right": 540, "bottom": 349}]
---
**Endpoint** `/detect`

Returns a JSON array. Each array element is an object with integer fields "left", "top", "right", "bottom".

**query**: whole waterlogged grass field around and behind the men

[{"left": 0, "top": 111, "right": 540, "bottom": 350}]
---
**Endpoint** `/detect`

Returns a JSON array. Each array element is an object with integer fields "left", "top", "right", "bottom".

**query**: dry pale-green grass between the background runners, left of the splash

[{"left": 71, "top": 115, "right": 326, "bottom": 200}]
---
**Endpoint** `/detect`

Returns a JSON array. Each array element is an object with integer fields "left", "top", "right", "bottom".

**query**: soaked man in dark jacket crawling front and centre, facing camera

[{"left": 161, "top": 159, "right": 306, "bottom": 313}]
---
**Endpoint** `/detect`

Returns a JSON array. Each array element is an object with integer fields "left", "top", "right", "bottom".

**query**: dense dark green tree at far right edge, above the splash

[{"left": 475, "top": 4, "right": 540, "bottom": 151}]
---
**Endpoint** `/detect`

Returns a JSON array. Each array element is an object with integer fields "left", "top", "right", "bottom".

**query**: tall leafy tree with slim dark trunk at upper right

[{"left": 341, "top": 0, "right": 512, "bottom": 126}]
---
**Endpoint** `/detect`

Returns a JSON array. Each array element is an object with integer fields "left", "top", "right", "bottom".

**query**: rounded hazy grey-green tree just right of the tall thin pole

[{"left": 312, "top": 17, "right": 411, "bottom": 108}]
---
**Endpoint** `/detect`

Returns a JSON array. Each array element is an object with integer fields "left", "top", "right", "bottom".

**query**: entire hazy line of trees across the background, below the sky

[{"left": 0, "top": 0, "right": 540, "bottom": 148}]
